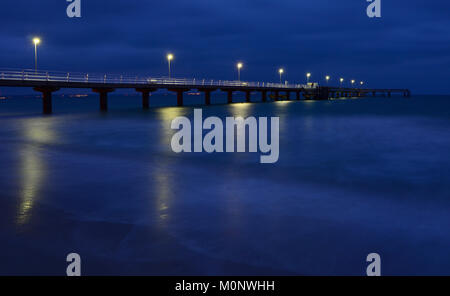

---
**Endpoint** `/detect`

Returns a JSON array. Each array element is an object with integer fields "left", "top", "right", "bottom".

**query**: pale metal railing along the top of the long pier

[{"left": 0, "top": 69, "right": 315, "bottom": 89}]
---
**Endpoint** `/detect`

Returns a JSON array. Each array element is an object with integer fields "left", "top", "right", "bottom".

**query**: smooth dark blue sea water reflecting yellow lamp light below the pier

[{"left": 0, "top": 95, "right": 450, "bottom": 275}]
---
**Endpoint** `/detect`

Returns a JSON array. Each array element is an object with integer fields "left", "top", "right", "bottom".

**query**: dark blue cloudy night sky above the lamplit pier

[{"left": 0, "top": 0, "right": 450, "bottom": 94}]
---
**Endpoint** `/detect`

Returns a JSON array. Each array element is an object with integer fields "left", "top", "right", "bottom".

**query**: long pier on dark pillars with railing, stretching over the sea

[{"left": 0, "top": 70, "right": 411, "bottom": 114}]
